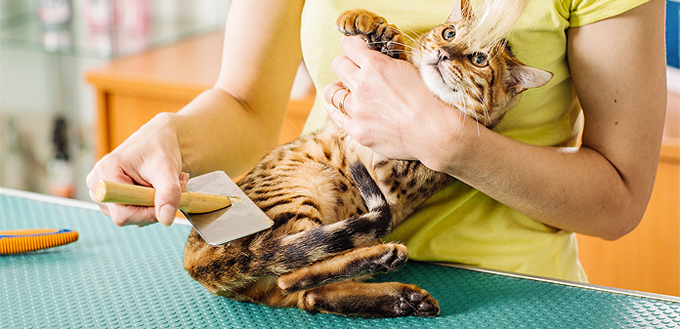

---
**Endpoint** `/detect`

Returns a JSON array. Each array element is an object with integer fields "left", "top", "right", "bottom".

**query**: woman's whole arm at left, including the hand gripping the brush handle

[{"left": 87, "top": 0, "right": 303, "bottom": 225}]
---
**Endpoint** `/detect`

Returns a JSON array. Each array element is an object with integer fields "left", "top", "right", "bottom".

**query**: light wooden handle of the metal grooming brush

[{"left": 95, "top": 181, "right": 231, "bottom": 214}]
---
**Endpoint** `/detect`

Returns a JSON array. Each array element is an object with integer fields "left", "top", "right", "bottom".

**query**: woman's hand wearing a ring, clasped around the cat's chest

[{"left": 324, "top": 36, "right": 465, "bottom": 165}]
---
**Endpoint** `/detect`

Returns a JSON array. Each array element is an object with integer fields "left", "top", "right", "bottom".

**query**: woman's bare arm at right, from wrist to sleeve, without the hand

[{"left": 452, "top": 1, "right": 666, "bottom": 239}]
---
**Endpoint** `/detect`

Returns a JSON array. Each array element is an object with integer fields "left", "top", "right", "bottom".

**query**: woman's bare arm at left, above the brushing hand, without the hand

[{"left": 176, "top": 0, "right": 304, "bottom": 177}]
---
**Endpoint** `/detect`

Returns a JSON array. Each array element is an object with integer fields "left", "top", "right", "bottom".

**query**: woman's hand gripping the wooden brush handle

[{"left": 87, "top": 113, "right": 188, "bottom": 226}]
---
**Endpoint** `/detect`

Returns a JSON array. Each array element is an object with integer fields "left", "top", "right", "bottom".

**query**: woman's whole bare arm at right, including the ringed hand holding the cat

[{"left": 324, "top": 0, "right": 666, "bottom": 239}]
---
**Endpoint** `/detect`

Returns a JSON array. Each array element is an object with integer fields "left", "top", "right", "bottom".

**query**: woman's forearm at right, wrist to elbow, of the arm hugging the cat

[{"left": 433, "top": 117, "right": 658, "bottom": 239}]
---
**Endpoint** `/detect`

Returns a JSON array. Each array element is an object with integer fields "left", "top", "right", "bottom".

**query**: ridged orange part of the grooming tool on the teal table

[{"left": 0, "top": 231, "right": 78, "bottom": 255}]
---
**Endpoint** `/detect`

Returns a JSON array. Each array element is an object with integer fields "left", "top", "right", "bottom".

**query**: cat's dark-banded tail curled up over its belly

[{"left": 268, "top": 162, "right": 392, "bottom": 273}]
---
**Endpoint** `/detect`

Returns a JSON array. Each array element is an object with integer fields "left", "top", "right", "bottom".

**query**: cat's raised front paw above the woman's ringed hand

[{"left": 335, "top": 9, "right": 408, "bottom": 60}]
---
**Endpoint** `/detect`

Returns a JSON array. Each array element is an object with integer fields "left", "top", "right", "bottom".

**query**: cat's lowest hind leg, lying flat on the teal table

[{"left": 300, "top": 281, "right": 439, "bottom": 317}]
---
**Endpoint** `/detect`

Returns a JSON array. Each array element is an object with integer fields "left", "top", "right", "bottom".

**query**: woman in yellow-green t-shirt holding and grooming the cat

[{"left": 87, "top": 0, "right": 666, "bottom": 281}]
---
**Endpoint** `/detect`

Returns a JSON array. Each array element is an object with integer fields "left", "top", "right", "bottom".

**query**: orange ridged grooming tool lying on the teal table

[{"left": 0, "top": 228, "right": 78, "bottom": 255}]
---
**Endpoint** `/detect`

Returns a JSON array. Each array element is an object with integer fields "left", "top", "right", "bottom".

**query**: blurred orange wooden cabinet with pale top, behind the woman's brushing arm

[{"left": 86, "top": 32, "right": 313, "bottom": 159}]
